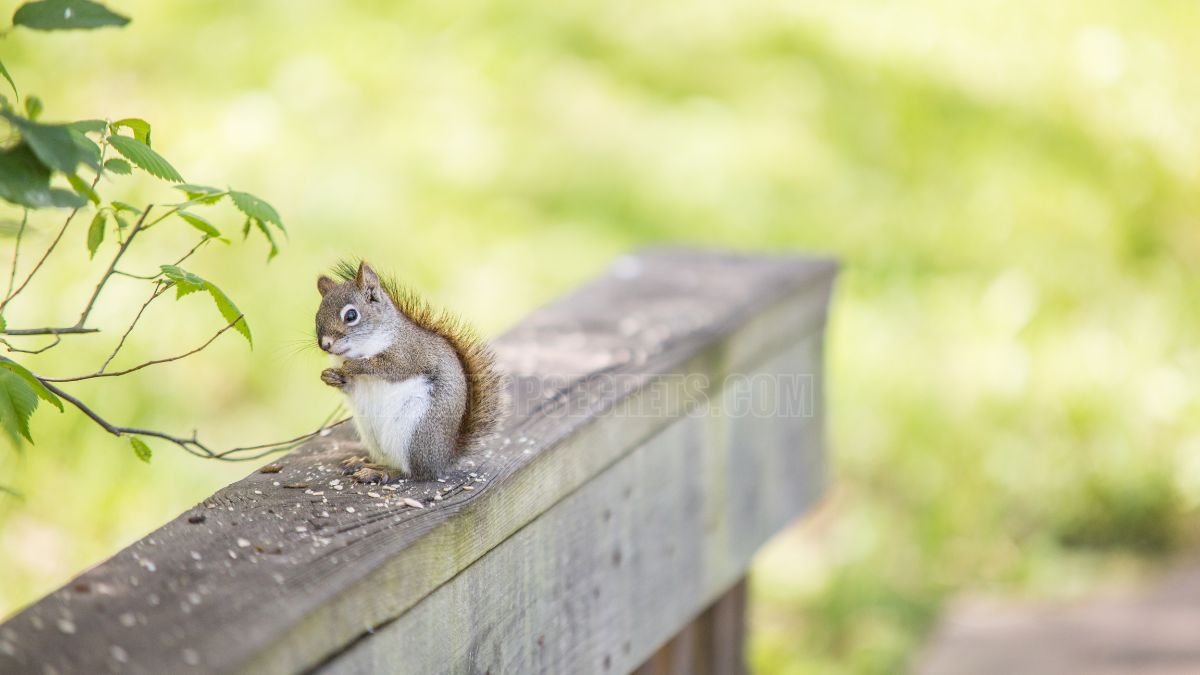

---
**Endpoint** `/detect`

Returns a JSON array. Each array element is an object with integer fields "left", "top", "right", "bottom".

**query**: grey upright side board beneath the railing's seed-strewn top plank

[{"left": 316, "top": 336, "right": 823, "bottom": 674}]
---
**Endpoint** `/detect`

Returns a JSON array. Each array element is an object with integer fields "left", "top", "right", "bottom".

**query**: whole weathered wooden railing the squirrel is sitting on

[{"left": 0, "top": 251, "right": 835, "bottom": 674}]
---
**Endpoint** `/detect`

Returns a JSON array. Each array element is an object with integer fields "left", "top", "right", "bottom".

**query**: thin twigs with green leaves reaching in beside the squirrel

[{"left": 0, "top": 0, "right": 333, "bottom": 461}]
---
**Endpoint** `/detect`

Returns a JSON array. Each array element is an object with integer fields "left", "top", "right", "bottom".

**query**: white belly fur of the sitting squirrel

[{"left": 344, "top": 375, "right": 433, "bottom": 473}]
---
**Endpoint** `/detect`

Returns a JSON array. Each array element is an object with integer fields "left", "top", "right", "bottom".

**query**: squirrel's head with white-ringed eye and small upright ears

[{"left": 317, "top": 262, "right": 402, "bottom": 359}]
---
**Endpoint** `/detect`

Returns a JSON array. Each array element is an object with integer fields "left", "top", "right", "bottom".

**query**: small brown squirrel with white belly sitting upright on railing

[{"left": 317, "top": 262, "right": 504, "bottom": 483}]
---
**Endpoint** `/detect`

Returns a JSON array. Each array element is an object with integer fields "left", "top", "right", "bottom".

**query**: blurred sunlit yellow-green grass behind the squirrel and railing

[{"left": 0, "top": 0, "right": 1200, "bottom": 673}]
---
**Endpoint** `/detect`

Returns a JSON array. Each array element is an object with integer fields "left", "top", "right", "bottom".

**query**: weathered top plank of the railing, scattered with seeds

[{"left": 0, "top": 250, "right": 836, "bottom": 671}]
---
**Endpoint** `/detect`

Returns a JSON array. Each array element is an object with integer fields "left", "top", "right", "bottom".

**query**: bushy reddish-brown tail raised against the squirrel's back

[{"left": 334, "top": 261, "right": 504, "bottom": 453}]
